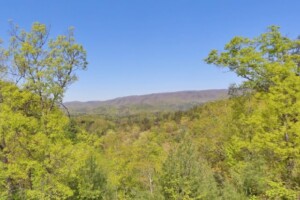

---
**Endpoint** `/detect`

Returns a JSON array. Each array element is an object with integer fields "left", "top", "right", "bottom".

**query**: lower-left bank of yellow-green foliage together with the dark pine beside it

[{"left": 0, "top": 82, "right": 109, "bottom": 199}]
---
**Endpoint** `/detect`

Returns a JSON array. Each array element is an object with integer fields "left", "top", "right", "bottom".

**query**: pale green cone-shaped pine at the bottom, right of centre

[{"left": 161, "top": 140, "right": 218, "bottom": 200}]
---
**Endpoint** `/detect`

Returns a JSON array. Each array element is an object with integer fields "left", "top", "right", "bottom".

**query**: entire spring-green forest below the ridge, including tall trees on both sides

[{"left": 0, "top": 23, "right": 300, "bottom": 200}]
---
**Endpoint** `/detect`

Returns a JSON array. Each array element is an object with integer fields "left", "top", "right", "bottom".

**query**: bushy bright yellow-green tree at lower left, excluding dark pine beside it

[{"left": 0, "top": 82, "right": 76, "bottom": 199}]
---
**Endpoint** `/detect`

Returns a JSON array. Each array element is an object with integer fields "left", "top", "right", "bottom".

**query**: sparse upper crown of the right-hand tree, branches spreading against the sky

[{"left": 205, "top": 26, "right": 300, "bottom": 91}]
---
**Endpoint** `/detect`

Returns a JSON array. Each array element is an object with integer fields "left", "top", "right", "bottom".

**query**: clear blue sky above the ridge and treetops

[{"left": 0, "top": 0, "right": 300, "bottom": 101}]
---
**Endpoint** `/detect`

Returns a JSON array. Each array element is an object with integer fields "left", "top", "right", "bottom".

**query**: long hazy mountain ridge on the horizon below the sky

[{"left": 65, "top": 89, "right": 228, "bottom": 116}]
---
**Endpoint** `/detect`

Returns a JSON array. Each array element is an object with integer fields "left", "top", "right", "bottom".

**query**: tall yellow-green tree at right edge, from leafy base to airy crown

[{"left": 206, "top": 26, "right": 300, "bottom": 199}]
